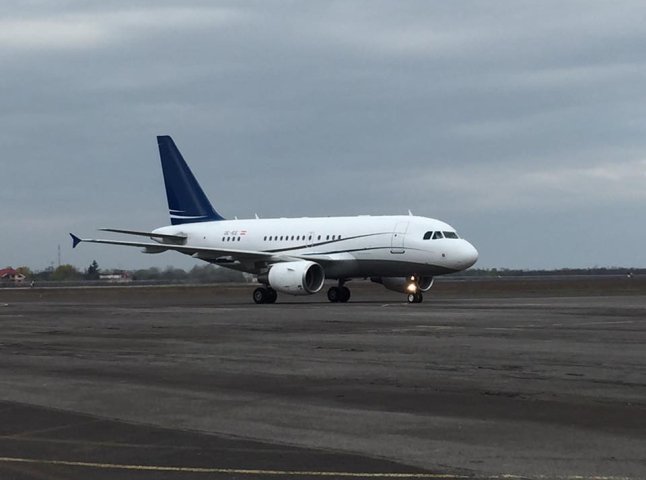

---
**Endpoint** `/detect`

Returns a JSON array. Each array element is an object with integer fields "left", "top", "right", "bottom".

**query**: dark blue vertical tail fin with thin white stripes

[{"left": 157, "top": 135, "right": 224, "bottom": 225}]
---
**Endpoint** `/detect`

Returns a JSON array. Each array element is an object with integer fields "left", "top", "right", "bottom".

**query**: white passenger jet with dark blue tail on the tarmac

[{"left": 70, "top": 136, "right": 478, "bottom": 304}]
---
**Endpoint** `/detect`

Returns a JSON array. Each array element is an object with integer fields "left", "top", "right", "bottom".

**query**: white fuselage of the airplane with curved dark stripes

[{"left": 155, "top": 215, "right": 478, "bottom": 279}]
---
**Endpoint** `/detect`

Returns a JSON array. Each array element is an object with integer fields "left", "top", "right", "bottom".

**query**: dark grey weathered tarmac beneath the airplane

[{"left": 0, "top": 278, "right": 646, "bottom": 480}]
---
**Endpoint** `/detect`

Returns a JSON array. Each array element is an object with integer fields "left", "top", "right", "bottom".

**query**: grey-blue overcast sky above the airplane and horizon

[{"left": 0, "top": 0, "right": 646, "bottom": 269}]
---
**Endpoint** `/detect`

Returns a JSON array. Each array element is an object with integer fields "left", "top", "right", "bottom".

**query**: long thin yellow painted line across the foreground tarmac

[{"left": 0, "top": 457, "right": 632, "bottom": 480}]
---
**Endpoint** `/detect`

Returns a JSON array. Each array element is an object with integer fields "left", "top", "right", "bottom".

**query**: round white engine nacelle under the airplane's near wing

[{"left": 267, "top": 260, "right": 325, "bottom": 295}]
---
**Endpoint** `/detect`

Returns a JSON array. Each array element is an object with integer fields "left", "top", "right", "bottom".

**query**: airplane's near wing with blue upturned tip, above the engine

[{"left": 70, "top": 232, "right": 332, "bottom": 263}]
